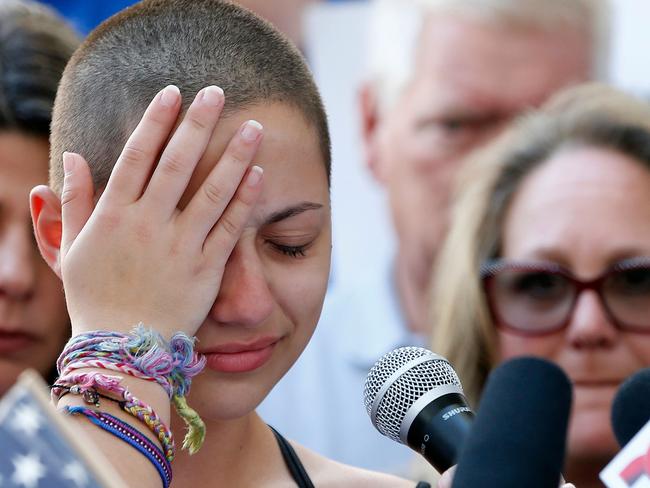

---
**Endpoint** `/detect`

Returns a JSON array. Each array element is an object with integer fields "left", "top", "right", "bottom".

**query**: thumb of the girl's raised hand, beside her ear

[{"left": 61, "top": 152, "right": 94, "bottom": 259}]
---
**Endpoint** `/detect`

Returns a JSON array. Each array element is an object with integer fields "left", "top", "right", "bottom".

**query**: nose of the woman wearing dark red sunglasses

[{"left": 567, "top": 290, "right": 618, "bottom": 349}]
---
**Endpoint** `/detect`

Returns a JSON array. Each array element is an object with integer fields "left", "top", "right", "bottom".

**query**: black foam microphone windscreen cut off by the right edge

[{"left": 612, "top": 368, "right": 650, "bottom": 447}]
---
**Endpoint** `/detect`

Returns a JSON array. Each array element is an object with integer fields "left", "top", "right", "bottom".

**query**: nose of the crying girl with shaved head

[{"left": 210, "top": 242, "right": 275, "bottom": 328}]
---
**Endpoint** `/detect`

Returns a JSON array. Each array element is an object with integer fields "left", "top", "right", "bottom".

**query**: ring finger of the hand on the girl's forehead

[{"left": 183, "top": 120, "right": 262, "bottom": 245}]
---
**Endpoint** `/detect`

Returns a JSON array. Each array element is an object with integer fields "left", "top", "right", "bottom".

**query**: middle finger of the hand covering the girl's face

[{"left": 143, "top": 86, "right": 224, "bottom": 215}]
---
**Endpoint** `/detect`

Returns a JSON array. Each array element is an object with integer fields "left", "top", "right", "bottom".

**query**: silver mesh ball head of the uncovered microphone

[{"left": 363, "top": 347, "right": 462, "bottom": 442}]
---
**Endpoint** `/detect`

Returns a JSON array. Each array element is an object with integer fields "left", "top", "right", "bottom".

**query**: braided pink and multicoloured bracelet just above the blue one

[{"left": 52, "top": 373, "right": 176, "bottom": 462}]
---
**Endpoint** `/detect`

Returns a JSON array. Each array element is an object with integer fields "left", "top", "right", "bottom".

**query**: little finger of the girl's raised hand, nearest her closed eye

[{"left": 203, "top": 166, "right": 264, "bottom": 258}]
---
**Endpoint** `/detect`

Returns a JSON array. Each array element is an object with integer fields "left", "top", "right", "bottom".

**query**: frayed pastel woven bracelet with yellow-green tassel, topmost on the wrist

[{"left": 57, "top": 324, "right": 205, "bottom": 454}]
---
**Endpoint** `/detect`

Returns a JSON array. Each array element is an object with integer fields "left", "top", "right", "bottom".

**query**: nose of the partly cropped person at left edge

[{"left": 0, "top": 225, "right": 36, "bottom": 300}]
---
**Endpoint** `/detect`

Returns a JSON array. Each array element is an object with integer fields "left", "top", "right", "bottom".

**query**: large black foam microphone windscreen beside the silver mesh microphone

[{"left": 453, "top": 357, "right": 572, "bottom": 488}]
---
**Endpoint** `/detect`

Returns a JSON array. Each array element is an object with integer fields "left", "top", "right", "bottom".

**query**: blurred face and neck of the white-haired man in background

[{"left": 361, "top": 0, "right": 601, "bottom": 333}]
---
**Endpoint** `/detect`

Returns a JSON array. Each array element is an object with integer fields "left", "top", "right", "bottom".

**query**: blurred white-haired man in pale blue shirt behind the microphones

[{"left": 261, "top": 0, "right": 604, "bottom": 474}]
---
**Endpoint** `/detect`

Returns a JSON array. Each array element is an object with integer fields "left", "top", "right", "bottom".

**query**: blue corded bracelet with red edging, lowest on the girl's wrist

[{"left": 62, "top": 406, "right": 172, "bottom": 488}]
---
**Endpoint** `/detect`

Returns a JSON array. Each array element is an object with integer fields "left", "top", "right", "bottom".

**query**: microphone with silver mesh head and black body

[{"left": 363, "top": 347, "right": 474, "bottom": 472}]
